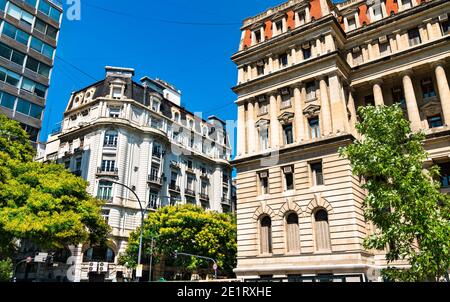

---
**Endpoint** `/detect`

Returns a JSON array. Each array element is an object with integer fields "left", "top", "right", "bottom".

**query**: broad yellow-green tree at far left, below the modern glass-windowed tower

[{"left": 0, "top": 115, "right": 110, "bottom": 268}]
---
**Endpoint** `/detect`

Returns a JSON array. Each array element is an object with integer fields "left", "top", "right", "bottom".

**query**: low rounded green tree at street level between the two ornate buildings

[{"left": 121, "top": 205, "right": 237, "bottom": 276}]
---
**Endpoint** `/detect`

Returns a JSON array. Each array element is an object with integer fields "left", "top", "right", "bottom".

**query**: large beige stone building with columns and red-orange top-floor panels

[{"left": 232, "top": 0, "right": 450, "bottom": 281}]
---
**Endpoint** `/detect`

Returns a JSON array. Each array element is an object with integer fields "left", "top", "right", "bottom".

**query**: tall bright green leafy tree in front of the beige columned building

[{"left": 340, "top": 105, "right": 450, "bottom": 281}]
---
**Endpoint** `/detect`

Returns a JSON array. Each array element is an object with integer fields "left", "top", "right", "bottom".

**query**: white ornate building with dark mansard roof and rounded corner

[{"left": 42, "top": 67, "right": 234, "bottom": 281}]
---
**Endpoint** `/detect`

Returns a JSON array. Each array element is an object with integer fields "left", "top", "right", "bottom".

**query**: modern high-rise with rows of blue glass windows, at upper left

[{"left": 0, "top": 0, "right": 62, "bottom": 146}]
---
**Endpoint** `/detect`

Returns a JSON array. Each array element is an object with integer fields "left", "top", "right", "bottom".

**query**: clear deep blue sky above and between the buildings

[{"left": 41, "top": 0, "right": 288, "bottom": 140}]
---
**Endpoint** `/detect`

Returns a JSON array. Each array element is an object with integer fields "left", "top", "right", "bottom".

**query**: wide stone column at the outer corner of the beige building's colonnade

[{"left": 328, "top": 74, "right": 349, "bottom": 133}]
